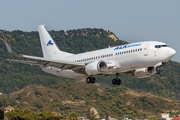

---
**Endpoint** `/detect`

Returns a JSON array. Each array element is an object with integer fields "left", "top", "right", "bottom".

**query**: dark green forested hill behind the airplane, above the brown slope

[{"left": 0, "top": 28, "right": 180, "bottom": 100}]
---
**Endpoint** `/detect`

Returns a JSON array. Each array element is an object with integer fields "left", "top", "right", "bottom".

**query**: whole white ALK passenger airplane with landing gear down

[{"left": 5, "top": 25, "right": 176, "bottom": 85}]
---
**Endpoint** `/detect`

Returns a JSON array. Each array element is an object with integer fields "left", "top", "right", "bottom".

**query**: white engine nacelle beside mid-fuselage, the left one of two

[{"left": 85, "top": 61, "right": 108, "bottom": 75}]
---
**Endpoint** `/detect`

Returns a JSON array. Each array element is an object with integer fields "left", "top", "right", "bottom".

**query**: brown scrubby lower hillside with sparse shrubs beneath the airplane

[{"left": 0, "top": 80, "right": 180, "bottom": 118}]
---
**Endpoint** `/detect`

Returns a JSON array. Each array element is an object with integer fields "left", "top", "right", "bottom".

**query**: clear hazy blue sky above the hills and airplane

[{"left": 0, "top": 0, "right": 180, "bottom": 62}]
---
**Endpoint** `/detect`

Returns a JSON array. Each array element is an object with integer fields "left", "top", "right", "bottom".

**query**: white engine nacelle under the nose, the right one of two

[{"left": 133, "top": 67, "right": 156, "bottom": 78}]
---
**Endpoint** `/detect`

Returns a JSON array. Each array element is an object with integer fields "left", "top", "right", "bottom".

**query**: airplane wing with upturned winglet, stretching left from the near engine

[{"left": 4, "top": 41, "right": 86, "bottom": 74}]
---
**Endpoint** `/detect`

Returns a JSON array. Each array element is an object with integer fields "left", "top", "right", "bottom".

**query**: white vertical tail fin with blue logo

[{"left": 38, "top": 25, "right": 73, "bottom": 58}]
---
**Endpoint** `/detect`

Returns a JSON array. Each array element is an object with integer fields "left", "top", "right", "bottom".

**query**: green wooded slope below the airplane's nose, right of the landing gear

[{"left": 97, "top": 61, "right": 180, "bottom": 100}]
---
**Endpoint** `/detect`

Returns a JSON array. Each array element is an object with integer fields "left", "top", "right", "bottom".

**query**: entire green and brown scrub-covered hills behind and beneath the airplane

[{"left": 0, "top": 28, "right": 180, "bottom": 119}]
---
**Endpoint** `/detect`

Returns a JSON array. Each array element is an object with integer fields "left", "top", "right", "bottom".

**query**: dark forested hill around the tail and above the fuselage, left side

[{"left": 0, "top": 28, "right": 127, "bottom": 93}]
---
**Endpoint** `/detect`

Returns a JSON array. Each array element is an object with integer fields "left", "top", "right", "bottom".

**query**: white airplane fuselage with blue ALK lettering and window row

[{"left": 42, "top": 41, "right": 174, "bottom": 78}]
